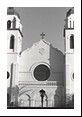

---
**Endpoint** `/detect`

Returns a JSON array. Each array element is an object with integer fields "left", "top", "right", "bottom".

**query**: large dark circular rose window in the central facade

[{"left": 34, "top": 64, "right": 50, "bottom": 81}]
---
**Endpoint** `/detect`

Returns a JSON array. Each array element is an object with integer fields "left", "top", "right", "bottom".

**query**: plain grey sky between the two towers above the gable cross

[{"left": 15, "top": 7, "right": 70, "bottom": 52}]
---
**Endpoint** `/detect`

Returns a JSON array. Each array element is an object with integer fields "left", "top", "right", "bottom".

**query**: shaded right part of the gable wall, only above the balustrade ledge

[{"left": 49, "top": 46, "right": 64, "bottom": 82}]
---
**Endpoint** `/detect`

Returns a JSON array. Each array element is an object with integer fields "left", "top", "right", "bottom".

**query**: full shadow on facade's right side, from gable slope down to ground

[{"left": 49, "top": 46, "right": 65, "bottom": 107}]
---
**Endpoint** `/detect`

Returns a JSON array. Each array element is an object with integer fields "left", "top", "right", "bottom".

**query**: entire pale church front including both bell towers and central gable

[{"left": 7, "top": 7, "right": 74, "bottom": 107}]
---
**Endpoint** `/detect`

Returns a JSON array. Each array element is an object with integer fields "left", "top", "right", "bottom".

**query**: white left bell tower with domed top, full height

[{"left": 7, "top": 7, "right": 23, "bottom": 106}]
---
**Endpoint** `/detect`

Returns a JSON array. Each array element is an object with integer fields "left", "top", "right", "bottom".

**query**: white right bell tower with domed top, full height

[{"left": 64, "top": 8, "right": 74, "bottom": 104}]
